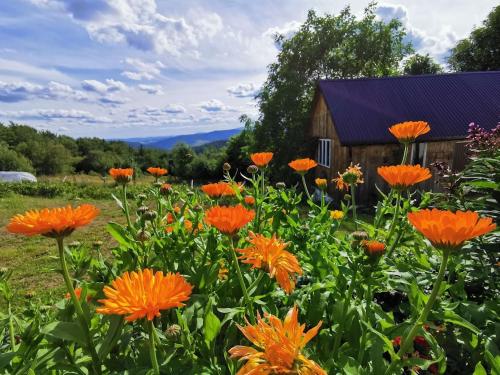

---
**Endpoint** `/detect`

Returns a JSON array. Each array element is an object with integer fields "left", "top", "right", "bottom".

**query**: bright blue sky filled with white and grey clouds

[{"left": 0, "top": 0, "right": 497, "bottom": 138}]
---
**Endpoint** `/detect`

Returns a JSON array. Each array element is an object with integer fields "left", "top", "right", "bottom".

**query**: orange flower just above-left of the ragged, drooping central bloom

[{"left": 205, "top": 204, "right": 255, "bottom": 235}]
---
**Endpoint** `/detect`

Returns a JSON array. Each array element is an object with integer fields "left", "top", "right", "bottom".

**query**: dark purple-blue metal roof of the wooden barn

[{"left": 319, "top": 71, "right": 500, "bottom": 145}]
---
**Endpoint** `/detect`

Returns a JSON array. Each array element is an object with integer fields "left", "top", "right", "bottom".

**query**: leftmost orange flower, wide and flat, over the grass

[{"left": 7, "top": 204, "right": 99, "bottom": 238}]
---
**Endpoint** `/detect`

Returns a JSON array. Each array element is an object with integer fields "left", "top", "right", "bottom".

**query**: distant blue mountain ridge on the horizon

[{"left": 120, "top": 128, "right": 243, "bottom": 150}]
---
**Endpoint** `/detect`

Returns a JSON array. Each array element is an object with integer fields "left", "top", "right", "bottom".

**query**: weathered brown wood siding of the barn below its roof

[{"left": 310, "top": 95, "right": 463, "bottom": 205}]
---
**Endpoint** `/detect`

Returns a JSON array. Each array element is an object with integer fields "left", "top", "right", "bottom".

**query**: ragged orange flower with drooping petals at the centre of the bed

[{"left": 238, "top": 232, "right": 302, "bottom": 294}]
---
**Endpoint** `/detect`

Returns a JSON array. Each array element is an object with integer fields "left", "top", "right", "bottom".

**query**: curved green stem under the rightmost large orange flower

[{"left": 385, "top": 250, "right": 450, "bottom": 375}]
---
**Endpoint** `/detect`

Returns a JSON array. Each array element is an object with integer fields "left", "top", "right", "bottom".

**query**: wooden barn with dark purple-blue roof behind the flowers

[{"left": 309, "top": 72, "right": 500, "bottom": 204}]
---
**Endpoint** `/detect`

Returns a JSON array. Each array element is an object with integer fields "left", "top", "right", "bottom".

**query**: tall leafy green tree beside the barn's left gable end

[{"left": 255, "top": 3, "right": 412, "bottom": 178}]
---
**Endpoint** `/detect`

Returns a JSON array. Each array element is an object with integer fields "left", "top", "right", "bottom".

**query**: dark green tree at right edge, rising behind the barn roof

[{"left": 448, "top": 5, "right": 500, "bottom": 72}]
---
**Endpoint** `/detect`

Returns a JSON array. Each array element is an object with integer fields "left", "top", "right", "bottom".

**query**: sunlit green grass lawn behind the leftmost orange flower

[{"left": 0, "top": 194, "right": 123, "bottom": 306}]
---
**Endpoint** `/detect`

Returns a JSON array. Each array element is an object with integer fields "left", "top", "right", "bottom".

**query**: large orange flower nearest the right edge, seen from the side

[{"left": 408, "top": 208, "right": 496, "bottom": 250}]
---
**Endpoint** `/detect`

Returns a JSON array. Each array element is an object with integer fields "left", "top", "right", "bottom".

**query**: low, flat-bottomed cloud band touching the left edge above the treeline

[{"left": 0, "top": 81, "right": 89, "bottom": 103}]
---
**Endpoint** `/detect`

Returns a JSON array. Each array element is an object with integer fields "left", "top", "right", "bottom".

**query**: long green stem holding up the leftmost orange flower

[{"left": 57, "top": 237, "right": 101, "bottom": 374}]
